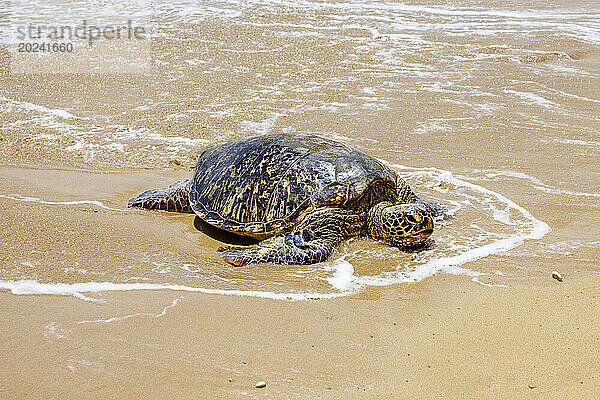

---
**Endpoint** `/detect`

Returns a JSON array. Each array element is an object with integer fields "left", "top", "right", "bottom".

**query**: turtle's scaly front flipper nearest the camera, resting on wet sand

[{"left": 217, "top": 208, "right": 365, "bottom": 267}]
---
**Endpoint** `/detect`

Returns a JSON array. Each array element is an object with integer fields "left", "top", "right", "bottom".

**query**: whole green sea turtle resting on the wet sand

[{"left": 129, "top": 133, "right": 443, "bottom": 266}]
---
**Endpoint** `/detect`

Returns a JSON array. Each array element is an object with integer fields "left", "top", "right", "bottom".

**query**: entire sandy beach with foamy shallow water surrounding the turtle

[{"left": 0, "top": 0, "right": 600, "bottom": 399}]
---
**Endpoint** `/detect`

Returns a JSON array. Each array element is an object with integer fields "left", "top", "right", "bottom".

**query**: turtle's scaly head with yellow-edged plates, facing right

[{"left": 367, "top": 201, "right": 433, "bottom": 247}]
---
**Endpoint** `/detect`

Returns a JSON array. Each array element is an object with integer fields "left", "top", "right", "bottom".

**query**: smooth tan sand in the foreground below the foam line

[{"left": 0, "top": 260, "right": 600, "bottom": 399}]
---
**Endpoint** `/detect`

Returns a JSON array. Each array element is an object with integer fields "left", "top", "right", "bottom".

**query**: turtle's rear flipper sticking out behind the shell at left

[{"left": 127, "top": 179, "right": 193, "bottom": 213}]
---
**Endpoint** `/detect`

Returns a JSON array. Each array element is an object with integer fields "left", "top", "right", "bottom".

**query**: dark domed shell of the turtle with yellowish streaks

[{"left": 190, "top": 133, "right": 401, "bottom": 239}]
